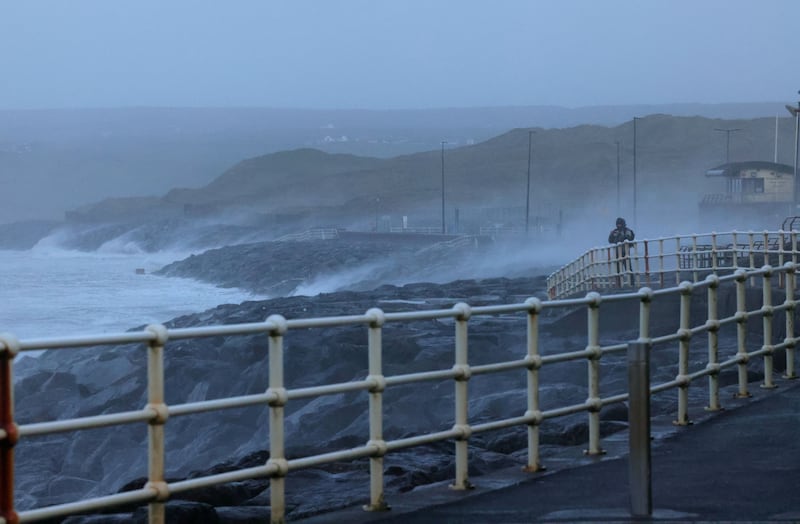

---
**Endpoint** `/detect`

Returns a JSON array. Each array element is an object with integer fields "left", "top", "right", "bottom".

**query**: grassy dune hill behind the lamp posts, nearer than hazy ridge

[{"left": 62, "top": 114, "right": 794, "bottom": 244}]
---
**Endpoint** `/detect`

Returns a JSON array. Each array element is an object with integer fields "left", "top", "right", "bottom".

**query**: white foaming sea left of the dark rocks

[{"left": 0, "top": 247, "right": 264, "bottom": 340}]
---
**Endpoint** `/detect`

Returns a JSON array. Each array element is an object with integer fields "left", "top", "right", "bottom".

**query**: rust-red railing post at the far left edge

[{"left": 0, "top": 333, "right": 19, "bottom": 524}]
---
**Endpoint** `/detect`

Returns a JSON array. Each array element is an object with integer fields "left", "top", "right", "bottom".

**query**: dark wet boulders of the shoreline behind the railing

[{"left": 10, "top": 238, "right": 780, "bottom": 524}]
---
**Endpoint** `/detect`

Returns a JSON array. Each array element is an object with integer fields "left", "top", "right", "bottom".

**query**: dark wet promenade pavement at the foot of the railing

[{"left": 299, "top": 379, "right": 800, "bottom": 524}]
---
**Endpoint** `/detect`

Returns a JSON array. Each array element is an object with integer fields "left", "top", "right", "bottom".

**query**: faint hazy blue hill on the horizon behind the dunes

[{"left": 0, "top": 102, "right": 788, "bottom": 223}]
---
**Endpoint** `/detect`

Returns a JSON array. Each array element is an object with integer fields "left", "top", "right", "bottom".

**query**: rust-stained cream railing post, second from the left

[{"left": 146, "top": 324, "right": 169, "bottom": 524}]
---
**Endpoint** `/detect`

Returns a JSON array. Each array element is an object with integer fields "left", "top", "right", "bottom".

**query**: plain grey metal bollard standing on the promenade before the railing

[{"left": 628, "top": 341, "right": 653, "bottom": 517}]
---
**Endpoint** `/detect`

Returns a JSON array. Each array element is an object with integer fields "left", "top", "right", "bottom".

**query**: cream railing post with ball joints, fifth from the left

[{"left": 450, "top": 302, "right": 473, "bottom": 490}]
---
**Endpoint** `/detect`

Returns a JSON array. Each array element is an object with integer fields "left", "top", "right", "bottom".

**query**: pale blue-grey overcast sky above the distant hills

[{"left": 0, "top": 0, "right": 800, "bottom": 109}]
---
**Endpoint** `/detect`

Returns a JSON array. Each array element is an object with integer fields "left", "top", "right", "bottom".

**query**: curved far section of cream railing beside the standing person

[{"left": 547, "top": 230, "right": 800, "bottom": 299}]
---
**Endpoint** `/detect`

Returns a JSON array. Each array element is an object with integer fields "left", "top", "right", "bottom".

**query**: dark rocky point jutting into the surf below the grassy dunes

[{"left": 157, "top": 233, "right": 556, "bottom": 300}]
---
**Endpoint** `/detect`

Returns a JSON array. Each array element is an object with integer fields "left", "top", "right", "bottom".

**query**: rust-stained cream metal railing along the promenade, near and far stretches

[{"left": 0, "top": 236, "right": 798, "bottom": 523}]
